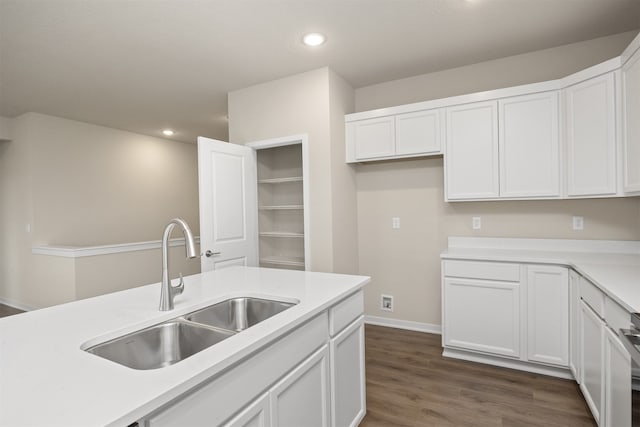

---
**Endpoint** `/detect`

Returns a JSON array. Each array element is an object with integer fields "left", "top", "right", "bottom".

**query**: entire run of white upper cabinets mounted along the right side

[{"left": 345, "top": 30, "right": 640, "bottom": 201}]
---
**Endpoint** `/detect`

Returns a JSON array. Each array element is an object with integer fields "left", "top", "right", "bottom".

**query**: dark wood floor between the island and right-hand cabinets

[{"left": 360, "top": 325, "right": 596, "bottom": 427}]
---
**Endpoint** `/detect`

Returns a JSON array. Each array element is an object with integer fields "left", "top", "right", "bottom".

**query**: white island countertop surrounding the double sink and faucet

[{"left": 0, "top": 267, "right": 369, "bottom": 426}]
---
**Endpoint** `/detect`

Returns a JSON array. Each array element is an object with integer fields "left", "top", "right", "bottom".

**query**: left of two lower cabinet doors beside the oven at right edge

[{"left": 580, "top": 301, "right": 604, "bottom": 424}]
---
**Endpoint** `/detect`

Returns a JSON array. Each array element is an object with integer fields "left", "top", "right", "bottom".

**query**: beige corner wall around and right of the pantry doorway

[{"left": 229, "top": 68, "right": 357, "bottom": 273}]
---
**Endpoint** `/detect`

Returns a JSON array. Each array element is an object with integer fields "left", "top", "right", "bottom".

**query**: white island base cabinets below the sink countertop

[{"left": 139, "top": 291, "right": 366, "bottom": 427}]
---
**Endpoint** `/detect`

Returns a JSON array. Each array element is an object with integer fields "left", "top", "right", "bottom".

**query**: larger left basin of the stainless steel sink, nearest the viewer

[{"left": 86, "top": 319, "right": 234, "bottom": 370}]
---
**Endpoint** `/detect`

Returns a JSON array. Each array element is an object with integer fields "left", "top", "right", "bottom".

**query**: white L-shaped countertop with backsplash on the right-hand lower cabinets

[{"left": 441, "top": 237, "right": 640, "bottom": 313}]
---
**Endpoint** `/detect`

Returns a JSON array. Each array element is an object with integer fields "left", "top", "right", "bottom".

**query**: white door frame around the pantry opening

[{"left": 244, "top": 133, "right": 311, "bottom": 270}]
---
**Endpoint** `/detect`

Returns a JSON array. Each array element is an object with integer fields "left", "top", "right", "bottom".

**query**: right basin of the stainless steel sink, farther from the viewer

[{"left": 184, "top": 297, "right": 295, "bottom": 332}]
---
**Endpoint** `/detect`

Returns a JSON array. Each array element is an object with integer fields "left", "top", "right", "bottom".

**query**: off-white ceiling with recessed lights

[{"left": 0, "top": 0, "right": 640, "bottom": 142}]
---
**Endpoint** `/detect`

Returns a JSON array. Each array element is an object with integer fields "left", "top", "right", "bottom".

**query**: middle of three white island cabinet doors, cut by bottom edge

[{"left": 271, "top": 345, "right": 330, "bottom": 427}]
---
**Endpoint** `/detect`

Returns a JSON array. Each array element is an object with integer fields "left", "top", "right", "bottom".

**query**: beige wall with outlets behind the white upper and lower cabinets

[{"left": 356, "top": 32, "right": 640, "bottom": 325}]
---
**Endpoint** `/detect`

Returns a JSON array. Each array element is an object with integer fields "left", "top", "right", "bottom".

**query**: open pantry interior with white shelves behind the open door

[{"left": 257, "top": 144, "right": 305, "bottom": 270}]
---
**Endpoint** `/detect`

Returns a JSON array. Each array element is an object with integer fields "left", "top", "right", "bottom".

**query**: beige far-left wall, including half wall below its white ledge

[{"left": 0, "top": 113, "right": 199, "bottom": 308}]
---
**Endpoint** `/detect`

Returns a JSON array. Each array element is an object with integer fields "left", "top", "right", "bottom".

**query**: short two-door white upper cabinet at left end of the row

[{"left": 346, "top": 109, "right": 442, "bottom": 162}]
